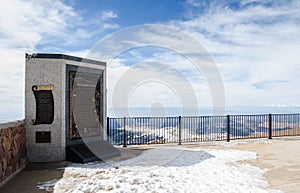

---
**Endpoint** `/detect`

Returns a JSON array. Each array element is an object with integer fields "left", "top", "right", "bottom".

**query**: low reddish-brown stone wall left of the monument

[{"left": 0, "top": 120, "right": 26, "bottom": 186}]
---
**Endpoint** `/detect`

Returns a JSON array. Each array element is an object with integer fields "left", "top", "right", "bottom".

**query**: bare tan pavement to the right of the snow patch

[{"left": 235, "top": 137, "right": 300, "bottom": 193}]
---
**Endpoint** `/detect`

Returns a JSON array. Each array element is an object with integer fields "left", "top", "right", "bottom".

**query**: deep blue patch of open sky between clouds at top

[{"left": 37, "top": 0, "right": 188, "bottom": 50}]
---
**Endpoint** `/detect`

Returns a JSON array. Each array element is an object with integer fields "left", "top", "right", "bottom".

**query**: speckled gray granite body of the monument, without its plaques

[{"left": 25, "top": 54, "right": 106, "bottom": 162}]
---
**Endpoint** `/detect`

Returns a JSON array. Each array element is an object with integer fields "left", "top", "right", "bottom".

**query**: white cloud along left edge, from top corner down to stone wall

[{"left": 0, "top": 0, "right": 78, "bottom": 119}]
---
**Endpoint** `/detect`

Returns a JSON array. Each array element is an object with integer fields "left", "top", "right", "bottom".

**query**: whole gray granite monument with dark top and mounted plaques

[{"left": 25, "top": 54, "right": 118, "bottom": 162}]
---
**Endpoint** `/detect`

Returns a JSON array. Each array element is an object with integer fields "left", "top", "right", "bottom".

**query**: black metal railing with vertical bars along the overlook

[{"left": 107, "top": 114, "right": 300, "bottom": 146}]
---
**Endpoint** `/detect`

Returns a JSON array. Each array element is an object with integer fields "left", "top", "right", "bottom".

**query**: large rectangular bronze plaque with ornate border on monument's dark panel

[{"left": 69, "top": 71, "right": 103, "bottom": 140}]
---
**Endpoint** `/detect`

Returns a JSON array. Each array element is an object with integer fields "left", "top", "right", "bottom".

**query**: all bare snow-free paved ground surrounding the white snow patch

[{"left": 0, "top": 137, "right": 300, "bottom": 193}]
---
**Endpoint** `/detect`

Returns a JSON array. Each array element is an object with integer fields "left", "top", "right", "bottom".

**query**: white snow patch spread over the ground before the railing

[{"left": 38, "top": 147, "right": 280, "bottom": 193}]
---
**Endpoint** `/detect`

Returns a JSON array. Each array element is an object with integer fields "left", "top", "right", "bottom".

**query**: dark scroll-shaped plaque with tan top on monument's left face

[{"left": 31, "top": 85, "right": 54, "bottom": 125}]
